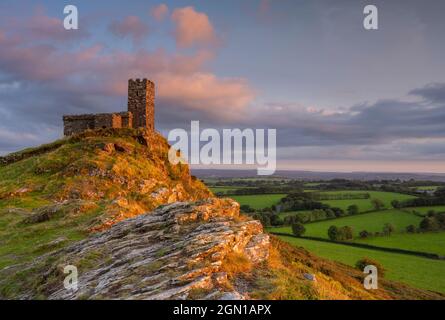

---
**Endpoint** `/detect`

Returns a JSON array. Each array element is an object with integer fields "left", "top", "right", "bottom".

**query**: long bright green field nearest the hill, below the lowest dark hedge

[{"left": 280, "top": 236, "right": 445, "bottom": 293}]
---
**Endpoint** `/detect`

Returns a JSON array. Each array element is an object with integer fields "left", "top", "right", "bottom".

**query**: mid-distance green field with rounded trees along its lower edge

[{"left": 271, "top": 209, "right": 422, "bottom": 239}]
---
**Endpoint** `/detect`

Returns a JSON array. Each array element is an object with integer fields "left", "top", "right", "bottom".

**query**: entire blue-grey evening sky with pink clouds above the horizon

[{"left": 0, "top": 0, "right": 445, "bottom": 173}]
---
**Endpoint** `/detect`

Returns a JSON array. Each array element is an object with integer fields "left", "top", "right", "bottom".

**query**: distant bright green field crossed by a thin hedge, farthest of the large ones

[{"left": 321, "top": 190, "right": 415, "bottom": 212}]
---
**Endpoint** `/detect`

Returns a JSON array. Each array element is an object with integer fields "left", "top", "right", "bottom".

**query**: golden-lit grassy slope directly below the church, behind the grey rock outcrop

[{"left": 0, "top": 129, "right": 210, "bottom": 269}]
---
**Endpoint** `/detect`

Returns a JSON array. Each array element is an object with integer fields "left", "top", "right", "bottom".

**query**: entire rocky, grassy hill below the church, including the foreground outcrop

[{"left": 0, "top": 129, "right": 443, "bottom": 299}]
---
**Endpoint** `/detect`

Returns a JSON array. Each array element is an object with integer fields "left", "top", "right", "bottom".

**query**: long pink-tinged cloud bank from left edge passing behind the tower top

[{"left": 0, "top": 17, "right": 254, "bottom": 119}]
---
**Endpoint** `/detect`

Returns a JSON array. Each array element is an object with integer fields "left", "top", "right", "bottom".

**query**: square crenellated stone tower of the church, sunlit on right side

[{"left": 128, "top": 79, "right": 155, "bottom": 131}]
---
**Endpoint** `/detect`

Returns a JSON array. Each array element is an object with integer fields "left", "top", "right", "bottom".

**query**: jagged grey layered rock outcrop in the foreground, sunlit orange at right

[{"left": 30, "top": 198, "right": 269, "bottom": 299}]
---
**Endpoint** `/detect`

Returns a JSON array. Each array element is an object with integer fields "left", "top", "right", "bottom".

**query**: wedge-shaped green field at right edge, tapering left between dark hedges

[{"left": 355, "top": 232, "right": 445, "bottom": 256}]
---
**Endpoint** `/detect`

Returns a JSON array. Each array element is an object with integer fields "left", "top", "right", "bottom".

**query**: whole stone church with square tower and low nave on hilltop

[{"left": 63, "top": 79, "right": 155, "bottom": 136}]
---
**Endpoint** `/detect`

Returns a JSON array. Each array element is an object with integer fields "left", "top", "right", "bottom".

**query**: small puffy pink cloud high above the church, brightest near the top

[{"left": 171, "top": 7, "right": 217, "bottom": 48}]
